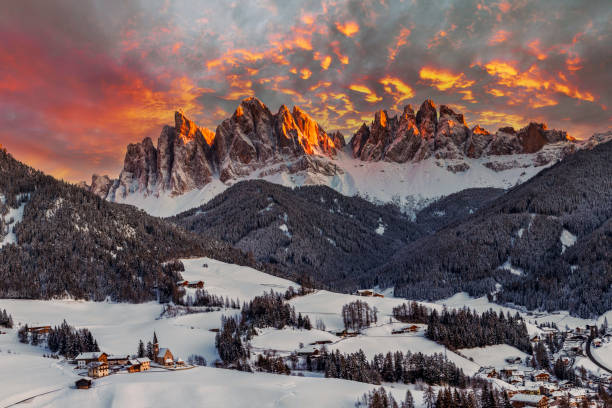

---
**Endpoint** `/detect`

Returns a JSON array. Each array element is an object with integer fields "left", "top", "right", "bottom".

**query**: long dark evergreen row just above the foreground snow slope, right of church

[{"left": 314, "top": 350, "right": 475, "bottom": 388}]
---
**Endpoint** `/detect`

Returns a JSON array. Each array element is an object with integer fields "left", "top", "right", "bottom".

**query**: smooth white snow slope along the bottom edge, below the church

[{"left": 20, "top": 367, "right": 422, "bottom": 408}]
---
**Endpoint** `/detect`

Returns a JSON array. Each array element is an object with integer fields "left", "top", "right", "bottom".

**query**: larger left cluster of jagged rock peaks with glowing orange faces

[{"left": 89, "top": 98, "right": 344, "bottom": 200}]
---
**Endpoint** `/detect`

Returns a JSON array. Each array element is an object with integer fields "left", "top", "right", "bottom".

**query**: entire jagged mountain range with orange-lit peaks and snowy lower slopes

[{"left": 87, "top": 98, "right": 609, "bottom": 216}]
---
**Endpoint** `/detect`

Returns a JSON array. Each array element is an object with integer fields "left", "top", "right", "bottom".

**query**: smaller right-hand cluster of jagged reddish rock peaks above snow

[{"left": 349, "top": 100, "right": 572, "bottom": 170}]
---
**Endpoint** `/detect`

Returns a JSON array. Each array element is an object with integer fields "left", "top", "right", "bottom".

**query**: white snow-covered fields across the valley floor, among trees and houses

[{"left": 0, "top": 258, "right": 610, "bottom": 407}]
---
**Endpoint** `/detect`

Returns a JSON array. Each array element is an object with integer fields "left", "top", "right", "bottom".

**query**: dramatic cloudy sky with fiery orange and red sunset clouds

[{"left": 0, "top": 0, "right": 612, "bottom": 181}]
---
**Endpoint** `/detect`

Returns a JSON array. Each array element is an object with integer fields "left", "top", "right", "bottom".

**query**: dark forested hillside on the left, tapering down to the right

[{"left": 0, "top": 149, "right": 258, "bottom": 302}]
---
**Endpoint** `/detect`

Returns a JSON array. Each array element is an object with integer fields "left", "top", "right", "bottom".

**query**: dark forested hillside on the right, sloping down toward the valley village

[{"left": 376, "top": 142, "right": 612, "bottom": 317}]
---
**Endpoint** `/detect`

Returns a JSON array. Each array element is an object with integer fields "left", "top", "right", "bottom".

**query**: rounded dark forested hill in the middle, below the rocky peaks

[{"left": 170, "top": 180, "right": 422, "bottom": 290}]
